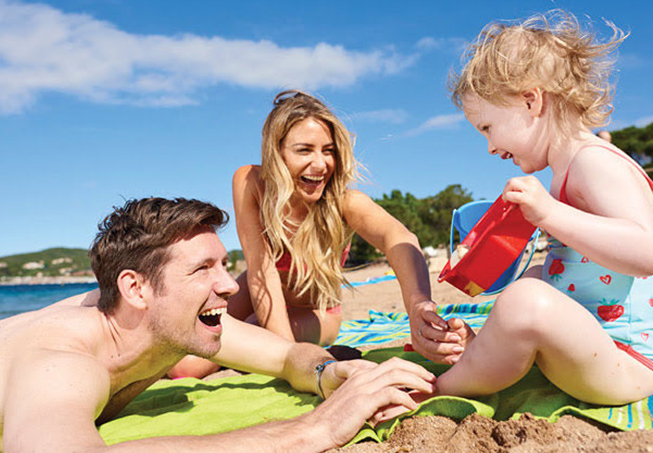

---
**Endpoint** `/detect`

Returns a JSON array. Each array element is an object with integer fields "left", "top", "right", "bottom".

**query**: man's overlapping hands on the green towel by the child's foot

[{"left": 305, "top": 357, "right": 435, "bottom": 447}]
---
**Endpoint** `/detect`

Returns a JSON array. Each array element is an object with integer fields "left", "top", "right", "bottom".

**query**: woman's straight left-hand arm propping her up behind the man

[{"left": 233, "top": 165, "right": 294, "bottom": 341}]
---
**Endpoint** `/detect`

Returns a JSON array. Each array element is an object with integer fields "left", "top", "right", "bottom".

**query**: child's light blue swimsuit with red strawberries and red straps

[{"left": 542, "top": 147, "right": 653, "bottom": 370}]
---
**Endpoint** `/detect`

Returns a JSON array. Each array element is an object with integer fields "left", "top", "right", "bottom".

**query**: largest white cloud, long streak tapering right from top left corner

[{"left": 0, "top": 0, "right": 416, "bottom": 114}]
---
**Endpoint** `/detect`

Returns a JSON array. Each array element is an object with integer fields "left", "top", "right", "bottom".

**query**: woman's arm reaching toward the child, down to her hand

[{"left": 344, "top": 190, "right": 472, "bottom": 363}]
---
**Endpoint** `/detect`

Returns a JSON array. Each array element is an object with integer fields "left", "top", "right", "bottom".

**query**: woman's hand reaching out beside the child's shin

[{"left": 409, "top": 300, "right": 475, "bottom": 364}]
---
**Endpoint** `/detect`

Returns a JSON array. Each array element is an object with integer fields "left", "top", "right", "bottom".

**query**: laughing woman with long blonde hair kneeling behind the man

[{"left": 168, "top": 91, "right": 458, "bottom": 376}]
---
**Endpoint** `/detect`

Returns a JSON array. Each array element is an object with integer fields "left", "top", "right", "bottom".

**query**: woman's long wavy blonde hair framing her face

[{"left": 261, "top": 90, "right": 358, "bottom": 310}]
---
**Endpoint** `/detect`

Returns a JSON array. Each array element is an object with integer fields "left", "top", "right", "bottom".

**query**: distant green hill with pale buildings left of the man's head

[{"left": 0, "top": 247, "right": 93, "bottom": 277}]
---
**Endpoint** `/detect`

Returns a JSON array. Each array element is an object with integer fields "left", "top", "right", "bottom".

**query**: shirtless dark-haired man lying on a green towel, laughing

[{"left": 0, "top": 198, "right": 435, "bottom": 453}]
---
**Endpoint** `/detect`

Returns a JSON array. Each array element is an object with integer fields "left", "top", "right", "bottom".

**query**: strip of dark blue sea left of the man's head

[{"left": 0, "top": 283, "right": 97, "bottom": 319}]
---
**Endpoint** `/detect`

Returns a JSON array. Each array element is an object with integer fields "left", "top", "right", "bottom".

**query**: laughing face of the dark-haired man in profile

[{"left": 150, "top": 228, "right": 238, "bottom": 358}]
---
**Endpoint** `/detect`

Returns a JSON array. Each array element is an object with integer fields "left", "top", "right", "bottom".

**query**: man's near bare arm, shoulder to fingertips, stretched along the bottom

[{"left": 4, "top": 338, "right": 433, "bottom": 453}]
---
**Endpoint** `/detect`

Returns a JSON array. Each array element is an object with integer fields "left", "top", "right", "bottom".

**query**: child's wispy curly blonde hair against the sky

[{"left": 449, "top": 10, "right": 628, "bottom": 131}]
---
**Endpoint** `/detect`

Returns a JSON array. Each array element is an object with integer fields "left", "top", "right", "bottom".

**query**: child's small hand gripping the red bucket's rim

[{"left": 503, "top": 176, "right": 555, "bottom": 227}]
